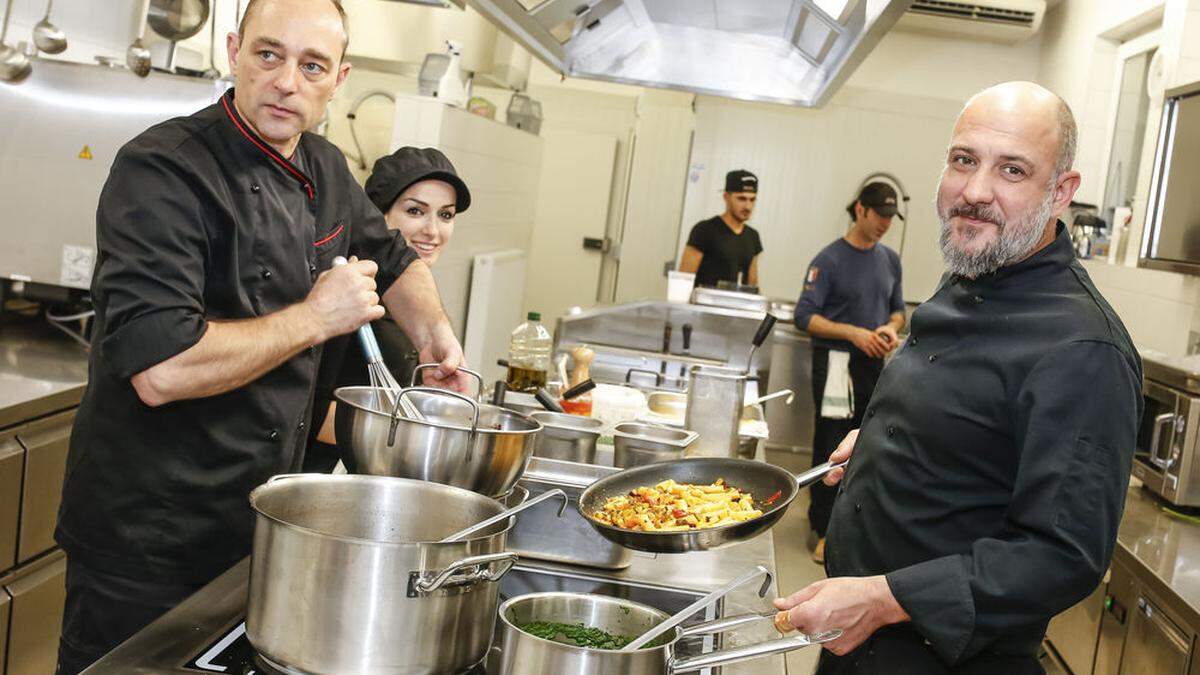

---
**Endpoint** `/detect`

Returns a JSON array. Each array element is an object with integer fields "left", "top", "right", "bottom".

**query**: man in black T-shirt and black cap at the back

[{"left": 679, "top": 169, "right": 762, "bottom": 286}]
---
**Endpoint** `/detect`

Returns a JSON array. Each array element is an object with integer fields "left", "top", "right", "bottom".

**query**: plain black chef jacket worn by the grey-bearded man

[{"left": 826, "top": 222, "right": 1142, "bottom": 673}]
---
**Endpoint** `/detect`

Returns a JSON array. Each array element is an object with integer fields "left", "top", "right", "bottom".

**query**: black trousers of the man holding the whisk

[{"left": 56, "top": 560, "right": 204, "bottom": 675}]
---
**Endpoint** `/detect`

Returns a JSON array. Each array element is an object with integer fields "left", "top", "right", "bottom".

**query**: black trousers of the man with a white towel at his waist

[{"left": 809, "top": 346, "right": 883, "bottom": 537}]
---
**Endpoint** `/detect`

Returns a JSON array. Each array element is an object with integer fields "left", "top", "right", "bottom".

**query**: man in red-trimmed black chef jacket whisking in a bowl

[{"left": 56, "top": 0, "right": 464, "bottom": 673}]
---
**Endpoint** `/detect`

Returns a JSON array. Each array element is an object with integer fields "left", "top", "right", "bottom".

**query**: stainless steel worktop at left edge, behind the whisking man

[{"left": 0, "top": 316, "right": 88, "bottom": 429}]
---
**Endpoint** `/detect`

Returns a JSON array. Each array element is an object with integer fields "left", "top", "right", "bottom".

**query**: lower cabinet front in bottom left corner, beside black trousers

[{"left": 2, "top": 551, "right": 67, "bottom": 675}]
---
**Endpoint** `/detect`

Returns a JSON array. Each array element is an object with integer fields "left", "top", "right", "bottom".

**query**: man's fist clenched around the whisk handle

[{"left": 302, "top": 258, "right": 384, "bottom": 342}]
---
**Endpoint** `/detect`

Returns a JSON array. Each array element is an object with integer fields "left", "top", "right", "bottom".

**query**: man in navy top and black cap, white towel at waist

[{"left": 796, "top": 183, "right": 905, "bottom": 562}]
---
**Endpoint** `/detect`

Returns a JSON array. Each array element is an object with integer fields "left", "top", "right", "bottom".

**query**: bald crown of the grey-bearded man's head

[{"left": 959, "top": 82, "right": 1079, "bottom": 175}]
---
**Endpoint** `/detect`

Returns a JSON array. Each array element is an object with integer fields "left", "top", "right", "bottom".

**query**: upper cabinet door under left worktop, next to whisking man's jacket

[{"left": 16, "top": 410, "right": 76, "bottom": 563}]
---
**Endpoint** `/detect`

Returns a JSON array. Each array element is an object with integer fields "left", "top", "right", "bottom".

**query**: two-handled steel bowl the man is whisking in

[{"left": 334, "top": 387, "right": 541, "bottom": 496}]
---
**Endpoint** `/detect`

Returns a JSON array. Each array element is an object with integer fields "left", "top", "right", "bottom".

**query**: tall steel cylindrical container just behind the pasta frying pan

[{"left": 684, "top": 365, "right": 746, "bottom": 458}]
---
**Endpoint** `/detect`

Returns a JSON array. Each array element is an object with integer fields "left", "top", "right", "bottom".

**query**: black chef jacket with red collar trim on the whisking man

[{"left": 56, "top": 90, "right": 416, "bottom": 581}]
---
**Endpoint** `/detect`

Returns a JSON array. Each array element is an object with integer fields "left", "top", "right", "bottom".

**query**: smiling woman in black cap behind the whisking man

[{"left": 304, "top": 147, "right": 470, "bottom": 473}]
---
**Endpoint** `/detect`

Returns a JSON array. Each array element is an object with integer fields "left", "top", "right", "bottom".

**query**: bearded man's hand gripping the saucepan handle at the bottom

[{"left": 775, "top": 577, "right": 908, "bottom": 656}]
